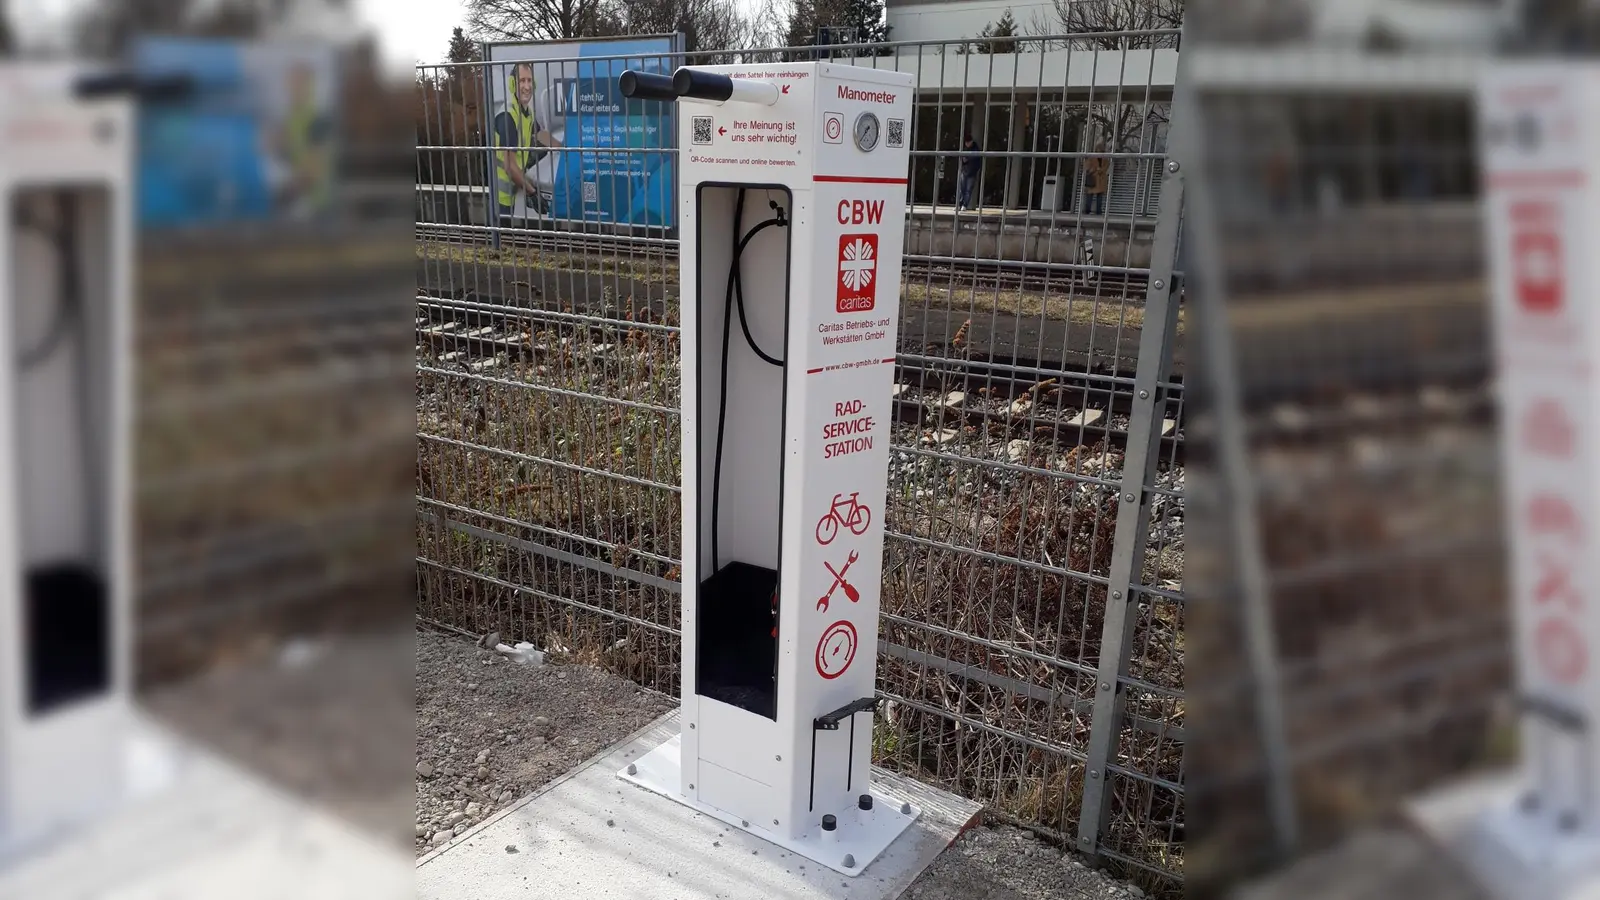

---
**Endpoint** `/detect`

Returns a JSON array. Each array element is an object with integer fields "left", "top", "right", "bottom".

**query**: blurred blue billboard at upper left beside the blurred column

[{"left": 133, "top": 37, "right": 339, "bottom": 227}]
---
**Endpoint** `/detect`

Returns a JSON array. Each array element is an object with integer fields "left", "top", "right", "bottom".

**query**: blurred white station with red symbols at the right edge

[{"left": 1413, "top": 62, "right": 1600, "bottom": 900}]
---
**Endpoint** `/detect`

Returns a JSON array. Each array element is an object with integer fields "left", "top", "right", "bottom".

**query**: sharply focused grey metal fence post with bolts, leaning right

[{"left": 1078, "top": 102, "right": 1187, "bottom": 857}]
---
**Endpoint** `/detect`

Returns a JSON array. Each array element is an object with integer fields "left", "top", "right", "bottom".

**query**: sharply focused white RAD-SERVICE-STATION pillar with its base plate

[{"left": 621, "top": 62, "right": 922, "bottom": 876}]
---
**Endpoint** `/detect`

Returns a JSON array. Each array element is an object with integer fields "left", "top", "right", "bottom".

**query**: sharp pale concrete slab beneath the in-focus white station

[{"left": 416, "top": 711, "right": 981, "bottom": 900}]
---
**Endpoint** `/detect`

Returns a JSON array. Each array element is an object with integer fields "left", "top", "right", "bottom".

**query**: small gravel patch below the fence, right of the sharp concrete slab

[{"left": 902, "top": 825, "right": 1144, "bottom": 900}]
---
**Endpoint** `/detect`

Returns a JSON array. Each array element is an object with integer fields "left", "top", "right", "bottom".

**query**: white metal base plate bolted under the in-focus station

[{"left": 618, "top": 735, "right": 922, "bottom": 876}]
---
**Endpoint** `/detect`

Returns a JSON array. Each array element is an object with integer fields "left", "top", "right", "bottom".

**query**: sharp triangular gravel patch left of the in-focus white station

[{"left": 416, "top": 629, "right": 672, "bottom": 855}]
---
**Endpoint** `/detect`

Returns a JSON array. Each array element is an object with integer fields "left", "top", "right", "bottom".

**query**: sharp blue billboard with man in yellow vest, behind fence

[{"left": 485, "top": 35, "right": 682, "bottom": 227}]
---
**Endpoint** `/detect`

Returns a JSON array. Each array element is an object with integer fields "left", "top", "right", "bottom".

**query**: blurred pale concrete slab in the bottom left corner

[{"left": 0, "top": 711, "right": 413, "bottom": 900}]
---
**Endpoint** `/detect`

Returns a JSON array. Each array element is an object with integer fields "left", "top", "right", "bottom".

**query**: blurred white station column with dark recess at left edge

[{"left": 0, "top": 57, "right": 134, "bottom": 863}]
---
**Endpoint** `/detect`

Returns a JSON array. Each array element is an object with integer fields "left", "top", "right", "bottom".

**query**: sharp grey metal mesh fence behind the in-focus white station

[{"left": 416, "top": 30, "right": 1186, "bottom": 890}]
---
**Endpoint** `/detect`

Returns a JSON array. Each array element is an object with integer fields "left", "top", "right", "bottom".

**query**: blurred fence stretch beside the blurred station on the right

[{"left": 1189, "top": 48, "right": 1509, "bottom": 881}]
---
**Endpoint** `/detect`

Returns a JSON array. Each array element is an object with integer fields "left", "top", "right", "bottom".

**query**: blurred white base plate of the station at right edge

[{"left": 1406, "top": 762, "right": 1600, "bottom": 900}]
